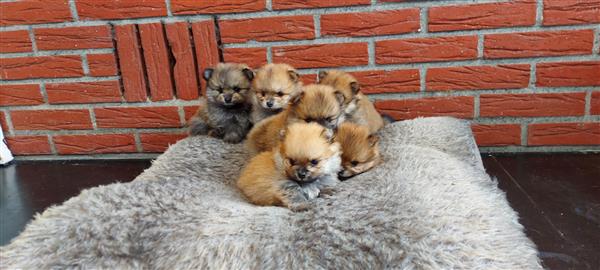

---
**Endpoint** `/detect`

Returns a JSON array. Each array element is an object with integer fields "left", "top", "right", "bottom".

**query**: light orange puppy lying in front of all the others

[{"left": 237, "top": 123, "right": 341, "bottom": 210}]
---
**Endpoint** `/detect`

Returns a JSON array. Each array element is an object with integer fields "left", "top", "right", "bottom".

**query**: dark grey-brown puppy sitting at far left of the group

[{"left": 188, "top": 63, "right": 254, "bottom": 143}]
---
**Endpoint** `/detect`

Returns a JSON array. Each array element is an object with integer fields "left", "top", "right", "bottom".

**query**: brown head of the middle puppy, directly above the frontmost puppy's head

[{"left": 288, "top": 84, "right": 344, "bottom": 129}]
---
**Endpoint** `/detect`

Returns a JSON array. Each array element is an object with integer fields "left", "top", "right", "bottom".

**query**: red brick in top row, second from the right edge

[{"left": 428, "top": 0, "right": 535, "bottom": 32}]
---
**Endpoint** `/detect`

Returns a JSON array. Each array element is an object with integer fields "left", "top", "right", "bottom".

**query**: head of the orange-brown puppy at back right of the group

[{"left": 319, "top": 69, "right": 360, "bottom": 113}]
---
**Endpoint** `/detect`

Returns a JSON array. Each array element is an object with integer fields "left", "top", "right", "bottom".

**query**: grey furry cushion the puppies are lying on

[{"left": 0, "top": 117, "right": 541, "bottom": 269}]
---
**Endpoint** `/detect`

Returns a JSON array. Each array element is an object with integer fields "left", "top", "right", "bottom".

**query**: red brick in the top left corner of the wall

[{"left": 0, "top": 0, "right": 72, "bottom": 26}]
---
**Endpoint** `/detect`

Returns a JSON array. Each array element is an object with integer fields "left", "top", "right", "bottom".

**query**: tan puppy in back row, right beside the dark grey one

[{"left": 250, "top": 64, "right": 302, "bottom": 124}]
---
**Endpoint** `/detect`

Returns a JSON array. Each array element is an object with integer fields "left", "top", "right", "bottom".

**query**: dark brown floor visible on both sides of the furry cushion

[{"left": 0, "top": 154, "right": 600, "bottom": 269}]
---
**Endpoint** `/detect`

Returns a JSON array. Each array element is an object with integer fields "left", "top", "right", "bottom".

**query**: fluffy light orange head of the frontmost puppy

[{"left": 279, "top": 123, "right": 341, "bottom": 184}]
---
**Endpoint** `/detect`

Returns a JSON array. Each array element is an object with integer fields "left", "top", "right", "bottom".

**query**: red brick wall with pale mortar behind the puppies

[{"left": 0, "top": 0, "right": 600, "bottom": 156}]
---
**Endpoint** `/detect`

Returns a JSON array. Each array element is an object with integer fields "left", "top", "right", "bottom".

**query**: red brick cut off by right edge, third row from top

[{"left": 536, "top": 61, "right": 600, "bottom": 86}]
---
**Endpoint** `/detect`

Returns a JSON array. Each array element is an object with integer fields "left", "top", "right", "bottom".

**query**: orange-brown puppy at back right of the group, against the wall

[{"left": 319, "top": 70, "right": 385, "bottom": 134}]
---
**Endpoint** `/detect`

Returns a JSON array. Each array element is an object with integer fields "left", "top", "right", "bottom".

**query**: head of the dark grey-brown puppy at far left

[{"left": 204, "top": 63, "right": 254, "bottom": 107}]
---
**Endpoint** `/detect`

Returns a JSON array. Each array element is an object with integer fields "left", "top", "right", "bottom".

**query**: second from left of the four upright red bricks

[{"left": 138, "top": 23, "right": 173, "bottom": 101}]
